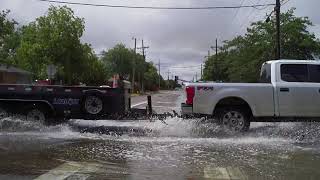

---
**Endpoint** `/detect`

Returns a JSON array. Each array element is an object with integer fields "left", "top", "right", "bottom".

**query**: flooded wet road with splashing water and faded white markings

[{"left": 0, "top": 91, "right": 320, "bottom": 179}]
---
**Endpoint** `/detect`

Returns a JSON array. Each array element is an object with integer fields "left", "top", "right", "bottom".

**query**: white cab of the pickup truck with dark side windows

[{"left": 260, "top": 60, "right": 320, "bottom": 118}]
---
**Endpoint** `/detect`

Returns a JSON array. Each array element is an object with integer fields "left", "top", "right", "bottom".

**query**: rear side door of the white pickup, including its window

[{"left": 276, "top": 64, "right": 318, "bottom": 117}]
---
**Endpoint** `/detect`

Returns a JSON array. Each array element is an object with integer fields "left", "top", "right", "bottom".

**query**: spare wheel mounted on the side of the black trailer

[{"left": 84, "top": 95, "right": 103, "bottom": 115}]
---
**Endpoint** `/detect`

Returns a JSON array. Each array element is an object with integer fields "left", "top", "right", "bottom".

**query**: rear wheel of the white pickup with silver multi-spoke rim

[{"left": 217, "top": 107, "right": 252, "bottom": 132}]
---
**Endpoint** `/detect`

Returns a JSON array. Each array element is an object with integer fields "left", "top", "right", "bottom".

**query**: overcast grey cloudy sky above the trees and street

[{"left": 0, "top": 0, "right": 320, "bottom": 80}]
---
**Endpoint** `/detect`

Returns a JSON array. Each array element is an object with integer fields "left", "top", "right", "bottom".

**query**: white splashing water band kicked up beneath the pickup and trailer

[{"left": 0, "top": 90, "right": 320, "bottom": 148}]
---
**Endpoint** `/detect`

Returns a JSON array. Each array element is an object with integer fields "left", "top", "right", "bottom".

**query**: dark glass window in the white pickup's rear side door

[{"left": 280, "top": 64, "right": 308, "bottom": 82}]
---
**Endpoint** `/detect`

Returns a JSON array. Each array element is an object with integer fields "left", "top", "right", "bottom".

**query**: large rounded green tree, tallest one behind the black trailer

[{"left": 16, "top": 6, "right": 107, "bottom": 84}]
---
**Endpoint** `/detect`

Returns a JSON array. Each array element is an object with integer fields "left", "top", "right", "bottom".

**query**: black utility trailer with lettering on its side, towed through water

[{"left": 0, "top": 81, "right": 131, "bottom": 123}]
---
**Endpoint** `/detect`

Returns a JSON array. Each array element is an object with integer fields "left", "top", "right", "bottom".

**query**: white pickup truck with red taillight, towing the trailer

[{"left": 181, "top": 60, "right": 320, "bottom": 131}]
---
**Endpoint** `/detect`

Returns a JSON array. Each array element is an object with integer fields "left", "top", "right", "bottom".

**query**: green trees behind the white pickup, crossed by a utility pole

[{"left": 204, "top": 8, "right": 320, "bottom": 82}]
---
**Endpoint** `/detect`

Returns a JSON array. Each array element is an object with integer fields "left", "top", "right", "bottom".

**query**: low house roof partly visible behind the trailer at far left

[{"left": 0, "top": 65, "right": 32, "bottom": 84}]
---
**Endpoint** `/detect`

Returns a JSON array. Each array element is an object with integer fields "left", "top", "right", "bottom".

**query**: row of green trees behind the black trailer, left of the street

[{"left": 0, "top": 6, "right": 164, "bottom": 90}]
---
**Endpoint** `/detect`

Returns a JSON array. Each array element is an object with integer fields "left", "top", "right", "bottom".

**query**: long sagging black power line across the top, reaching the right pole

[{"left": 38, "top": 0, "right": 275, "bottom": 10}]
